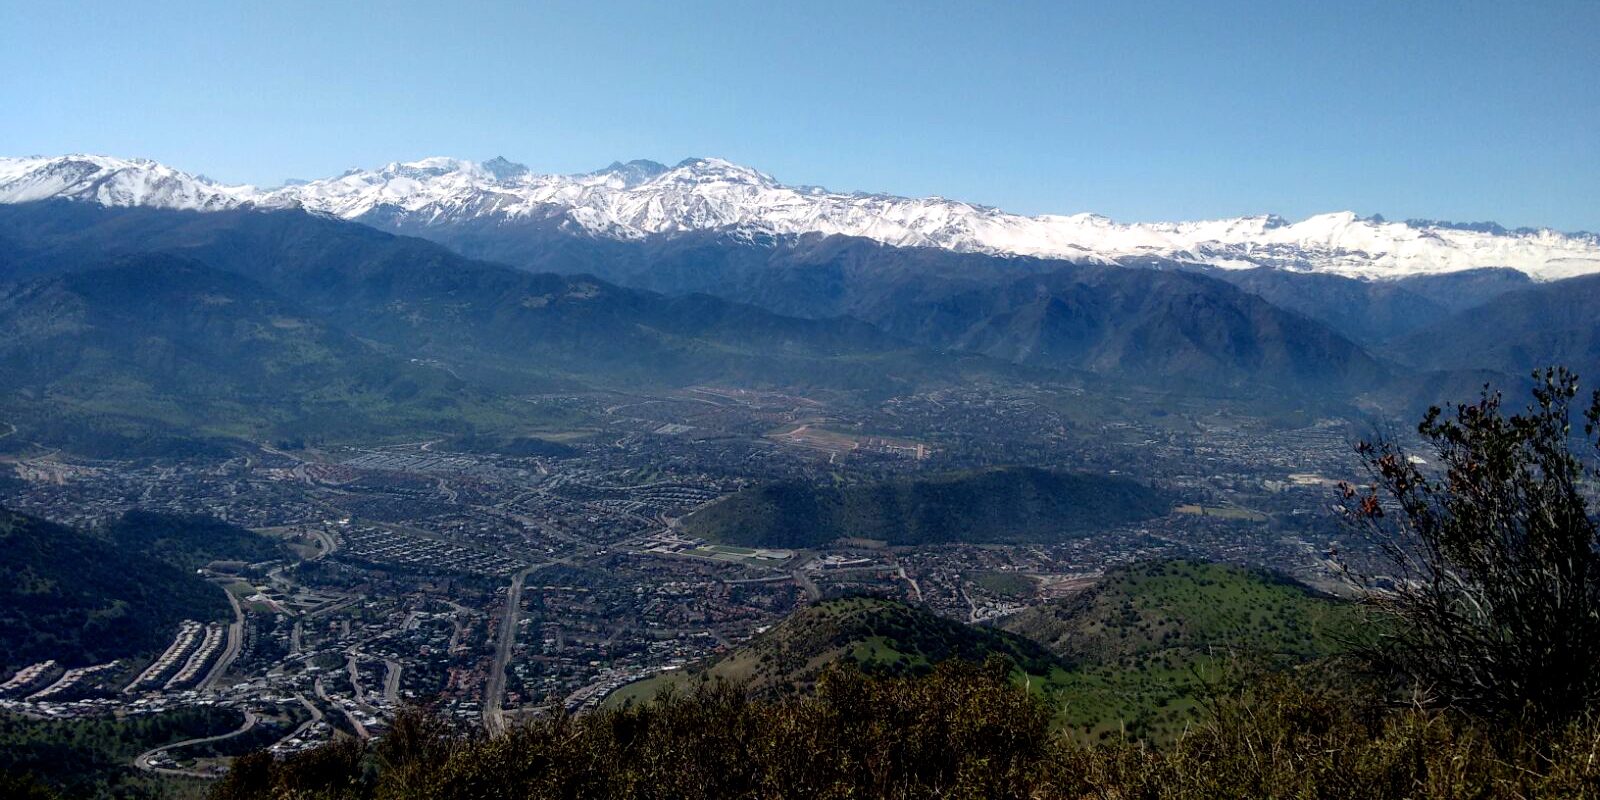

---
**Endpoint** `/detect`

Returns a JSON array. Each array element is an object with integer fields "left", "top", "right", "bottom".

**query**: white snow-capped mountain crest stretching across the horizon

[{"left": 0, "top": 155, "right": 1600, "bottom": 280}]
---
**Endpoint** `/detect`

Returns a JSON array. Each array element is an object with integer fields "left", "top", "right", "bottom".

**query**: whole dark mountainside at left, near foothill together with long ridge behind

[{"left": 0, "top": 203, "right": 1014, "bottom": 448}]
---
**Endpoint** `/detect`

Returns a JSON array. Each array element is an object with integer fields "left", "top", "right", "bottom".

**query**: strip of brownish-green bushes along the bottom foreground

[{"left": 213, "top": 662, "right": 1600, "bottom": 800}]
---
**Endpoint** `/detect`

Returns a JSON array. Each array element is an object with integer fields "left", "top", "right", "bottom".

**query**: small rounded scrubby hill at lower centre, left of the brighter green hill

[{"left": 608, "top": 597, "right": 1069, "bottom": 706}]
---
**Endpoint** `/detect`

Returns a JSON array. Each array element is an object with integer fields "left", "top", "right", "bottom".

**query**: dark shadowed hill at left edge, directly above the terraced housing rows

[{"left": 0, "top": 509, "right": 229, "bottom": 674}]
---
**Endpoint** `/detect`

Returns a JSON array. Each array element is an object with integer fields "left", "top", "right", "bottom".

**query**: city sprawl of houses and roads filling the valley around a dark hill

[{"left": 0, "top": 380, "right": 1376, "bottom": 774}]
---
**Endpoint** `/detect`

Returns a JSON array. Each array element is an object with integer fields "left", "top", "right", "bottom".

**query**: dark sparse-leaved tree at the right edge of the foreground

[{"left": 1344, "top": 368, "right": 1600, "bottom": 723}]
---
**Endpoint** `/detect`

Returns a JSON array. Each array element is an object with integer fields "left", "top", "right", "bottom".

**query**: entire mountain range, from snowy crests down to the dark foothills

[{"left": 0, "top": 157, "right": 1600, "bottom": 454}]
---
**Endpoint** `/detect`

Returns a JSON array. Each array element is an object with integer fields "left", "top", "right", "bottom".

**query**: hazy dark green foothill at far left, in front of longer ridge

[{"left": 0, "top": 256, "right": 509, "bottom": 456}]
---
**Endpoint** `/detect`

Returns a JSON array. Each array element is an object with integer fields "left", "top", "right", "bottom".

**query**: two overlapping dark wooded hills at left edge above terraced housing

[{"left": 0, "top": 509, "right": 277, "bottom": 672}]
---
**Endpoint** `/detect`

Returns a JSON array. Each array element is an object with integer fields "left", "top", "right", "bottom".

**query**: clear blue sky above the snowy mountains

[{"left": 0, "top": 0, "right": 1600, "bottom": 230}]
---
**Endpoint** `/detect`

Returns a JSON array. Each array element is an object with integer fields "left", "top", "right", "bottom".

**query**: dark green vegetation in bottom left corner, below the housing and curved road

[{"left": 0, "top": 707, "right": 240, "bottom": 800}]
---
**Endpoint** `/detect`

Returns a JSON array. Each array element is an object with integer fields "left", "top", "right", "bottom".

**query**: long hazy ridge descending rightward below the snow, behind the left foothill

[{"left": 0, "top": 203, "right": 1021, "bottom": 400}]
